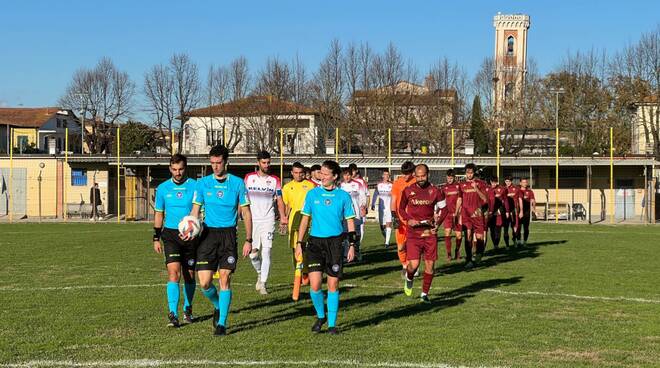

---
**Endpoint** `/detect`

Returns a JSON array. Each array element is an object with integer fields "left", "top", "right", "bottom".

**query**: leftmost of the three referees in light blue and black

[{"left": 153, "top": 154, "right": 197, "bottom": 327}]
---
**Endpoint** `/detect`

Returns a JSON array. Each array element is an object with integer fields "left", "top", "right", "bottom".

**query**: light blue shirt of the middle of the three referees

[{"left": 193, "top": 174, "right": 250, "bottom": 227}]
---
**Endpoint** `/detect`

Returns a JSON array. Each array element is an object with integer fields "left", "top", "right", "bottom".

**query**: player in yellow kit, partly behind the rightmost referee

[{"left": 282, "top": 162, "right": 316, "bottom": 294}]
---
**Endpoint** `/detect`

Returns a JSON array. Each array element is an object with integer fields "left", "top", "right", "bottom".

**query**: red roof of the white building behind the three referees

[{"left": 186, "top": 96, "right": 317, "bottom": 117}]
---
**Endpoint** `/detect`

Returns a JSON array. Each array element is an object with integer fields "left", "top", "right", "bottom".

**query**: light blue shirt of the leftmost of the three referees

[{"left": 154, "top": 178, "right": 197, "bottom": 229}]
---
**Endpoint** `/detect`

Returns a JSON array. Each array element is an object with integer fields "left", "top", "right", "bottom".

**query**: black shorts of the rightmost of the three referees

[{"left": 305, "top": 234, "right": 344, "bottom": 278}]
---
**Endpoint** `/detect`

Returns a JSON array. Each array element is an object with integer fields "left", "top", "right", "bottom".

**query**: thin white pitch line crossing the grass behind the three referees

[{"left": 0, "top": 282, "right": 660, "bottom": 304}]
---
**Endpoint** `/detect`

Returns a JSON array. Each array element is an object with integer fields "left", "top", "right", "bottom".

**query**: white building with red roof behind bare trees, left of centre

[{"left": 183, "top": 96, "right": 325, "bottom": 154}]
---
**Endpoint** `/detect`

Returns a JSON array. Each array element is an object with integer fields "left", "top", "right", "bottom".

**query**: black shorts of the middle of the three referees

[{"left": 197, "top": 227, "right": 238, "bottom": 272}]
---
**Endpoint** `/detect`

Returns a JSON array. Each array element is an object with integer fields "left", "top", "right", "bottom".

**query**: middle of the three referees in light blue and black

[{"left": 190, "top": 145, "right": 252, "bottom": 336}]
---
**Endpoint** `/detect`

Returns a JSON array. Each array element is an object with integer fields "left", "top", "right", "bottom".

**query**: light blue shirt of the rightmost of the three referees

[{"left": 301, "top": 187, "right": 355, "bottom": 238}]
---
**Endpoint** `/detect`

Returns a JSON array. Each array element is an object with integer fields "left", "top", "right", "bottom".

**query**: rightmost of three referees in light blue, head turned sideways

[{"left": 296, "top": 161, "right": 357, "bottom": 335}]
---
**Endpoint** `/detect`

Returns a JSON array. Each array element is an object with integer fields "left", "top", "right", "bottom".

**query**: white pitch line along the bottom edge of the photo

[{"left": 0, "top": 359, "right": 508, "bottom": 368}]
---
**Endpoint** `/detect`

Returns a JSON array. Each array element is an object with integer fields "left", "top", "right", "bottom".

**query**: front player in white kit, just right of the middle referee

[{"left": 245, "top": 151, "right": 288, "bottom": 295}]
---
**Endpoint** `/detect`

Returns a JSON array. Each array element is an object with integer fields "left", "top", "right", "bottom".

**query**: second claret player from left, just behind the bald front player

[{"left": 440, "top": 169, "right": 462, "bottom": 261}]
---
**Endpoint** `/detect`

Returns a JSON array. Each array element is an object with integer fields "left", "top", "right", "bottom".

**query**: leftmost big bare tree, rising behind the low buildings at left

[{"left": 59, "top": 57, "right": 135, "bottom": 153}]
